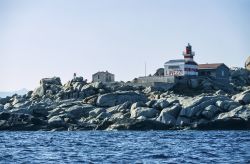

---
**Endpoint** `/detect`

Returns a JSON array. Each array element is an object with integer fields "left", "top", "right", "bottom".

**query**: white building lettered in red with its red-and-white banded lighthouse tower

[{"left": 164, "top": 43, "right": 198, "bottom": 76}]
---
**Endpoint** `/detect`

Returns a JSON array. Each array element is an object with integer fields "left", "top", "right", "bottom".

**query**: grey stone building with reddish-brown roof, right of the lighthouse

[{"left": 198, "top": 63, "right": 230, "bottom": 83}]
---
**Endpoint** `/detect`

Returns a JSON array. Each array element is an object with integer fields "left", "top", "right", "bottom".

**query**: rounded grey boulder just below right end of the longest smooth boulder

[{"left": 130, "top": 107, "right": 159, "bottom": 118}]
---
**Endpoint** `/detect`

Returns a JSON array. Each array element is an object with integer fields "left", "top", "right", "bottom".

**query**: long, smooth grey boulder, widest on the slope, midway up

[{"left": 96, "top": 91, "right": 147, "bottom": 107}]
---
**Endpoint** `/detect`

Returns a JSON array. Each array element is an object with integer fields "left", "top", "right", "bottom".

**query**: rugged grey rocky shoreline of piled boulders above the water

[{"left": 0, "top": 69, "right": 250, "bottom": 131}]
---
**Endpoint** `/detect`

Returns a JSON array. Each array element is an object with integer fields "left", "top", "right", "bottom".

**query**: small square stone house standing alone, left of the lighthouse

[{"left": 92, "top": 71, "right": 115, "bottom": 83}]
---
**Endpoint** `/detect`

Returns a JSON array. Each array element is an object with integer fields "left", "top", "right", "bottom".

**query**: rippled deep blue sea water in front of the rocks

[{"left": 0, "top": 131, "right": 250, "bottom": 164}]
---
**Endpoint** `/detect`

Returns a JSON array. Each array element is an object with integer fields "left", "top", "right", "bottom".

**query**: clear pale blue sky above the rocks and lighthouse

[{"left": 0, "top": 0, "right": 250, "bottom": 91}]
